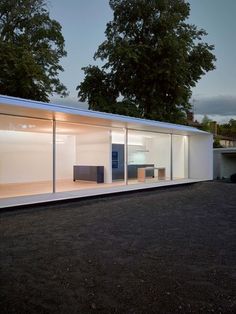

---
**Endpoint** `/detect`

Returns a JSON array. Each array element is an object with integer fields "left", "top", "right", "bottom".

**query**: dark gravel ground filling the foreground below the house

[{"left": 0, "top": 182, "right": 236, "bottom": 314}]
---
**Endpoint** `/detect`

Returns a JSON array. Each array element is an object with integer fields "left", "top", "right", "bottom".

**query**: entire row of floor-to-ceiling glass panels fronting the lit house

[{"left": 0, "top": 115, "right": 188, "bottom": 198}]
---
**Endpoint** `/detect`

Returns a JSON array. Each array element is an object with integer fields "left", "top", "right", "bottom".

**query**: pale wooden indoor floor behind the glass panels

[{"left": 0, "top": 178, "right": 172, "bottom": 198}]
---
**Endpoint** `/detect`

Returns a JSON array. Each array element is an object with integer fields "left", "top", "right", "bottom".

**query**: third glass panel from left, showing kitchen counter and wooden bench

[{"left": 128, "top": 130, "right": 171, "bottom": 184}]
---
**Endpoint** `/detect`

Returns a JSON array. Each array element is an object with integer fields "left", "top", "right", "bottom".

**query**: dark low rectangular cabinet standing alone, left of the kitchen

[{"left": 73, "top": 165, "right": 104, "bottom": 183}]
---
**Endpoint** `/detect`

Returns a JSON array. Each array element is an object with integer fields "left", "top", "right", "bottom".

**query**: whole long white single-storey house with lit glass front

[{"left": 0, "top": 96, "right": 213, "bottom": 207}]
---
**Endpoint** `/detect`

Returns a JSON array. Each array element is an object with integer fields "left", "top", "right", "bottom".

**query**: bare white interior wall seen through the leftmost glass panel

[{"left": 0, "top": 130, "right": 52, "bottom": 184}]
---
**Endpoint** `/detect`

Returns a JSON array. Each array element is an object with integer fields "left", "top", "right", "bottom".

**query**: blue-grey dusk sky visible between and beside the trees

[{"left": 48, "top": 0, "right": 236, "bottom": 123}]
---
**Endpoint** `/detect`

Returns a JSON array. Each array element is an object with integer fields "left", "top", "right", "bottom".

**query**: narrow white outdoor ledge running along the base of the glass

[{"left": 0, "top": 179, "right": 203, "bottom": 209}]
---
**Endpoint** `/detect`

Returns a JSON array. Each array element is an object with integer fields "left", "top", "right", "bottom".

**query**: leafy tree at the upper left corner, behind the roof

[{"left": 0, "top": 0, "right": 67, "bottom": 101}]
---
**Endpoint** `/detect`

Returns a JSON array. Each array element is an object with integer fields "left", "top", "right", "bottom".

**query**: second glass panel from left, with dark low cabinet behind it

[{"left": 56, "top": 122, "right": 124, "bottom": 191}]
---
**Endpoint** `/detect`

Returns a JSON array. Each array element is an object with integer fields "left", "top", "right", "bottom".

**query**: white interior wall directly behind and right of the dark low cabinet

[{"left": 76, "top": 128, "right": 112, "bottom": 183}]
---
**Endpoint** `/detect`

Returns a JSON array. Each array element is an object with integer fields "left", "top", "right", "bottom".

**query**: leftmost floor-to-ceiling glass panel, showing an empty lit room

[{"left": 0, "top": 115, "right": 52, "bottom": 198}]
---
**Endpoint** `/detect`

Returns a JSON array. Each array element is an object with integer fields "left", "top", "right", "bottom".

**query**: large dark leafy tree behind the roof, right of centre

[{"left": 77, "top": 0, "right": 216, "bottom": 122}]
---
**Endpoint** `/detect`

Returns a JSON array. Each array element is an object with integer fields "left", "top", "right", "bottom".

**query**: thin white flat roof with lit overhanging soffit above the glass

[{"left": 0, "top": 95, "right": 210, "bottom": 135}]
